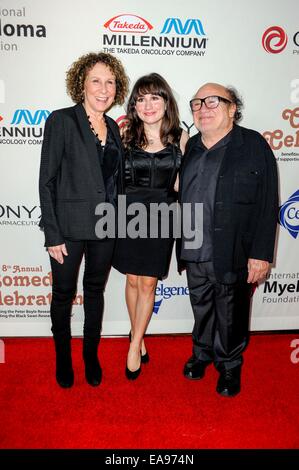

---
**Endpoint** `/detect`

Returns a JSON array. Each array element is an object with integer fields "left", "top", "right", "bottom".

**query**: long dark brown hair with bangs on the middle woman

[{"left": 123, "top": 73, "right": 181, "bottom": 147}]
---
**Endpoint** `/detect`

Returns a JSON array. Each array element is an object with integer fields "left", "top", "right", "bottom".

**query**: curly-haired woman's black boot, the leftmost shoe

[{"left": 54, "top": 337, "right": 74, "bottom": 388}]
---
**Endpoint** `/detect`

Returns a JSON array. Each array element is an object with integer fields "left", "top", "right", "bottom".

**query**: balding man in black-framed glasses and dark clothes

[{"left": 179, "top": 83, "right": 278, "bottom": 396}]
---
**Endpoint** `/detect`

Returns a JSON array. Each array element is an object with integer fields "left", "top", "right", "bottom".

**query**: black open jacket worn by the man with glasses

[{"left": 177, "top": 125, "right": 278, "bottom": 283}]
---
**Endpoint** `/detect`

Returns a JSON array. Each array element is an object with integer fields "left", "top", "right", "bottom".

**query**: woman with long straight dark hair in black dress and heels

[{"left": 113, "top": 73, "right": 188, "bottom": 379}]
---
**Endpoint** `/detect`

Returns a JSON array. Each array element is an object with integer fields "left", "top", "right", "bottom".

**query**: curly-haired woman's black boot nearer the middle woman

[{"left": 83, "top": 338, "right": 102, "bottom": 387}]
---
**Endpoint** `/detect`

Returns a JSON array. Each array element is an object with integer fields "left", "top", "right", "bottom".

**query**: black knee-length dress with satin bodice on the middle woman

[{"left": 113, "top": 144, "right": 181, "bottom": 279}]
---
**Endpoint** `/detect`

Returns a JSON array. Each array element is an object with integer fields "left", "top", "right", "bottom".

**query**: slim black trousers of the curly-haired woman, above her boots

[{"left": 50, "top": 239, "right": 115, "bottom": 339}]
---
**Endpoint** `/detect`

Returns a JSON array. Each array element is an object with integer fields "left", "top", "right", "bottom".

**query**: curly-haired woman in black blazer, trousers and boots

[{"left": 39, "top": 52, "right": 128, "bottom": 388}]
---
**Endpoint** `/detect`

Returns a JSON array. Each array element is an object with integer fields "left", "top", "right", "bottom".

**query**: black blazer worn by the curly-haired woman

[{"left": 39, "top": 104, "right": 124, "bottom": 246}]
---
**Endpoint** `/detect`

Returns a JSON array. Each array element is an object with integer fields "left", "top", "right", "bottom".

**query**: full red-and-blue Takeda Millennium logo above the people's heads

[{"left": 102, "top": 14, "right": 208, "bottom": 57}]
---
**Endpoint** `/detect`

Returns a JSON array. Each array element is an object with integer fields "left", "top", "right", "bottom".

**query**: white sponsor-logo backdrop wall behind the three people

[{"left": 0, "top": 0, "right": 299, "bottom": 336}]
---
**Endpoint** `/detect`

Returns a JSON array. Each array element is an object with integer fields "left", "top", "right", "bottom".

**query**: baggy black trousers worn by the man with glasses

[{"left": 187, "top": 262, "right": 252, "bottom": 370}]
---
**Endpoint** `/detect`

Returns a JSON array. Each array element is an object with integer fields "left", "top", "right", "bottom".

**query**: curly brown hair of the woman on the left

[{"left": 66, "top": 52, "right": 129, "bottom": 105}]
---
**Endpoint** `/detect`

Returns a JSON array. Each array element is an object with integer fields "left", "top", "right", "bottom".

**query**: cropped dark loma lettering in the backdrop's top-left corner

[{"left": 0, "top": 6, "right": 47, "bottom": 53}]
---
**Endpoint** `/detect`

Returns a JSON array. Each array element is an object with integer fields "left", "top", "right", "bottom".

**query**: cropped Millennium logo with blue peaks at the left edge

[{"left": 0, "top": 109, "right": 50, "bottom": 145}]
